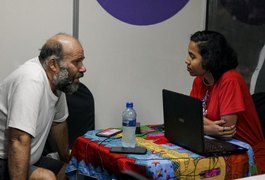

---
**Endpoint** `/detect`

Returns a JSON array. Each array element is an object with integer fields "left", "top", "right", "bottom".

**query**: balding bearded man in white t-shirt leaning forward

[{"left": 0, "top": 33, "right": 86, "bottom": 180}]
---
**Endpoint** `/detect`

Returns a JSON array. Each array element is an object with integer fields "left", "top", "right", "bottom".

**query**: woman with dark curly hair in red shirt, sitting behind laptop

[{"left": 185, "top": 31, "right": 265, "bottom": 174}]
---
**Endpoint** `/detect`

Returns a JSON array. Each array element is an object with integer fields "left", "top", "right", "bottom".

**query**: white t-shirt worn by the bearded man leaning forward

[{"left": 0, "top": 57, "right": 68, "bottom": 164}]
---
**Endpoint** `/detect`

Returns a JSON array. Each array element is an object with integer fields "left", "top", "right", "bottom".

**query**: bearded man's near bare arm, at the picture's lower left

[{"left": 8, "top": 127, "right": 32, "bottom": 180}]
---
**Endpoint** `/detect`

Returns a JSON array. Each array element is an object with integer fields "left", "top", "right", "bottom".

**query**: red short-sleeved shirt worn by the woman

[{"left": 190, "top": 70, "right": 264, "bottom": 146}]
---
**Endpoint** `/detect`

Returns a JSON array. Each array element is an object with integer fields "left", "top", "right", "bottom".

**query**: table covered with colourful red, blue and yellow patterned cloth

[{"left": 66, "top": 125, "right": 256, "bottom": 179}]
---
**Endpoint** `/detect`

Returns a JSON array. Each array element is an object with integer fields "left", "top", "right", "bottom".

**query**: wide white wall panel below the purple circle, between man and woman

[{"left": 79, "top": 0, "right": 206, "bottom": 128}]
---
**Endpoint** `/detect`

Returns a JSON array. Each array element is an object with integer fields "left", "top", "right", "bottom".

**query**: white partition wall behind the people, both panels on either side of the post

[{"left": 0, "top": 0, "right": 206, "bottom": 128}]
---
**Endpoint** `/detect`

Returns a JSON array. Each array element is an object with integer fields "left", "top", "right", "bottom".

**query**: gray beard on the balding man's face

[{"left": 53, "top": 67, "right": 79, "bottom": 94}]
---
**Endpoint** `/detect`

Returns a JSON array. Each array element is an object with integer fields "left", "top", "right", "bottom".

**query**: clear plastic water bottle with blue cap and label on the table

[{"left": 121, "top": 102, "right": 136, "bottom": 147}]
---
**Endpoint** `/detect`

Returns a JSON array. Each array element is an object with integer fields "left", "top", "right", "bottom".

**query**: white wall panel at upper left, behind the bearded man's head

[{"left": 0, "top": 0, "right": 73, "bottom": 80}]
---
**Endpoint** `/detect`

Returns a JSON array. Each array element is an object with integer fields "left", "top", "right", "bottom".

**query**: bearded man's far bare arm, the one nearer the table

[{"left": 50, "top": 121, "right": 69, "bottom": 163}]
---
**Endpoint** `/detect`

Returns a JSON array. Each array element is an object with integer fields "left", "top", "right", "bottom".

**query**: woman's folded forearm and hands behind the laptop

[{"left": 203, "top": 115, "right": 236, "bottom": 139}]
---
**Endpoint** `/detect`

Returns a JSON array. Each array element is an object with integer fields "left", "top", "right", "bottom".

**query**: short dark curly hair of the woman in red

[{"left": 190, "top": 31, "right": 238, "bottom": 81}]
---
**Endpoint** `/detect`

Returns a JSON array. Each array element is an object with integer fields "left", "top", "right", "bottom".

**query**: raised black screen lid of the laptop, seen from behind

[{"left": 163, "top": 89, "right": 204, "bottom": 152}]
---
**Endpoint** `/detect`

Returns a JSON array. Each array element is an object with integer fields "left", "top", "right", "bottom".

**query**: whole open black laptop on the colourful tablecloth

[{"left": 162, "top": 89, "right": 247, "bottom": 156}]
